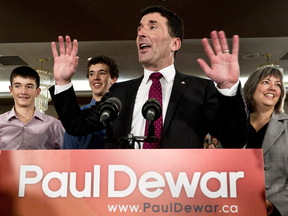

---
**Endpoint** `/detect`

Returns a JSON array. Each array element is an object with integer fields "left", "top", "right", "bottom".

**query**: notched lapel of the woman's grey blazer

[{"left": 262, "top": 113, "right": 287, "bottom": 154}]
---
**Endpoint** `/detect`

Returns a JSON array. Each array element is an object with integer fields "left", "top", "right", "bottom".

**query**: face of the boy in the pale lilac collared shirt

[{"left": 9, "top": 76, "right": 41, "bottom": 108}]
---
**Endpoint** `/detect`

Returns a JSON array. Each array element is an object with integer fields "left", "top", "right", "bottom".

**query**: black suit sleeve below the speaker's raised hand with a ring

[{"left": 203, "top": 81, "right": 249, "bottom": 148}]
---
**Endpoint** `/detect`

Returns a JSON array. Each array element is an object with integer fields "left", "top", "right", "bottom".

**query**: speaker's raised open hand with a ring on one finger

[{"left": 197, "top": 31, "right": 240, "bottom": 89}]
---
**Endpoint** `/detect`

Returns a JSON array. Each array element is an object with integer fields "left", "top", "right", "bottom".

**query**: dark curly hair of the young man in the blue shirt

[{"left": 86, "top": 55, "right": 119, "bottom": 79}]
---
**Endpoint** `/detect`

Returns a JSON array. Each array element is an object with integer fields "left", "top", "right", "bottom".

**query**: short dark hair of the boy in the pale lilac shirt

[{"left": 10, "top": 66, "right": 40, "bottom": 89}]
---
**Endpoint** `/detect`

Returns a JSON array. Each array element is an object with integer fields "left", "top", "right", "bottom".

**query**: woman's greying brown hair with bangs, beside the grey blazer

[{"left": 243, "top": 67, "right": 285, "bottom": 113}]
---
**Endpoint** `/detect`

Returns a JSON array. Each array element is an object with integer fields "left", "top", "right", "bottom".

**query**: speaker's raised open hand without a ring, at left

[{"left": 51, "top": 36, "right": 79, "bottom": 85}]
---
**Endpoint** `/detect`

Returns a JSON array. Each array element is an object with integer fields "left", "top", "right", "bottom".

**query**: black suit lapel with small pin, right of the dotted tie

[{"left": 162, "top": 71, "right": 189, "bottom": 135}]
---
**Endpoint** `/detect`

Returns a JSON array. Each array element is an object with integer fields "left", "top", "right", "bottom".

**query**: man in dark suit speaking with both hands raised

[{"left": 50, "top": 6, "right": 247, "bottom": 148}]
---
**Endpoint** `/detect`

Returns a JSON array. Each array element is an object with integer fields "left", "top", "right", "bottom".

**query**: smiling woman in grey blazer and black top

[{"left": 243, "top": 67, "right": 288, "bottom": 215}]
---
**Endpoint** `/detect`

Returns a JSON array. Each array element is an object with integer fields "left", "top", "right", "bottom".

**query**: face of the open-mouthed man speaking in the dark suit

[{"left": 136, "top": 13, "right": 178, "bottom": 71}]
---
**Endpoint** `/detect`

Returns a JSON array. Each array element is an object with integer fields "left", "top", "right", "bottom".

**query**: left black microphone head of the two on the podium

[{"left": 99, "top": 97, "right": 122, "bottom": 123}]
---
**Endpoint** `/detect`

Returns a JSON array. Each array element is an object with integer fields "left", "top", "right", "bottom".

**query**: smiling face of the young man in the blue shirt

[{"left": 88, "top": 63, "right": 117, "bottom": 101}]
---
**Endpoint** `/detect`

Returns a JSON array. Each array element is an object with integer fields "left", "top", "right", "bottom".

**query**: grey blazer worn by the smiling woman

[{"left": 262, "top": 113, "right": 288, "bottom": 216}]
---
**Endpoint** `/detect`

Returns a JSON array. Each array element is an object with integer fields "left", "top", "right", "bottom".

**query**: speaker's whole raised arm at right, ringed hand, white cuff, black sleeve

[{"left": 198, "top": 31, "right": 249, "bottom": 148}]
